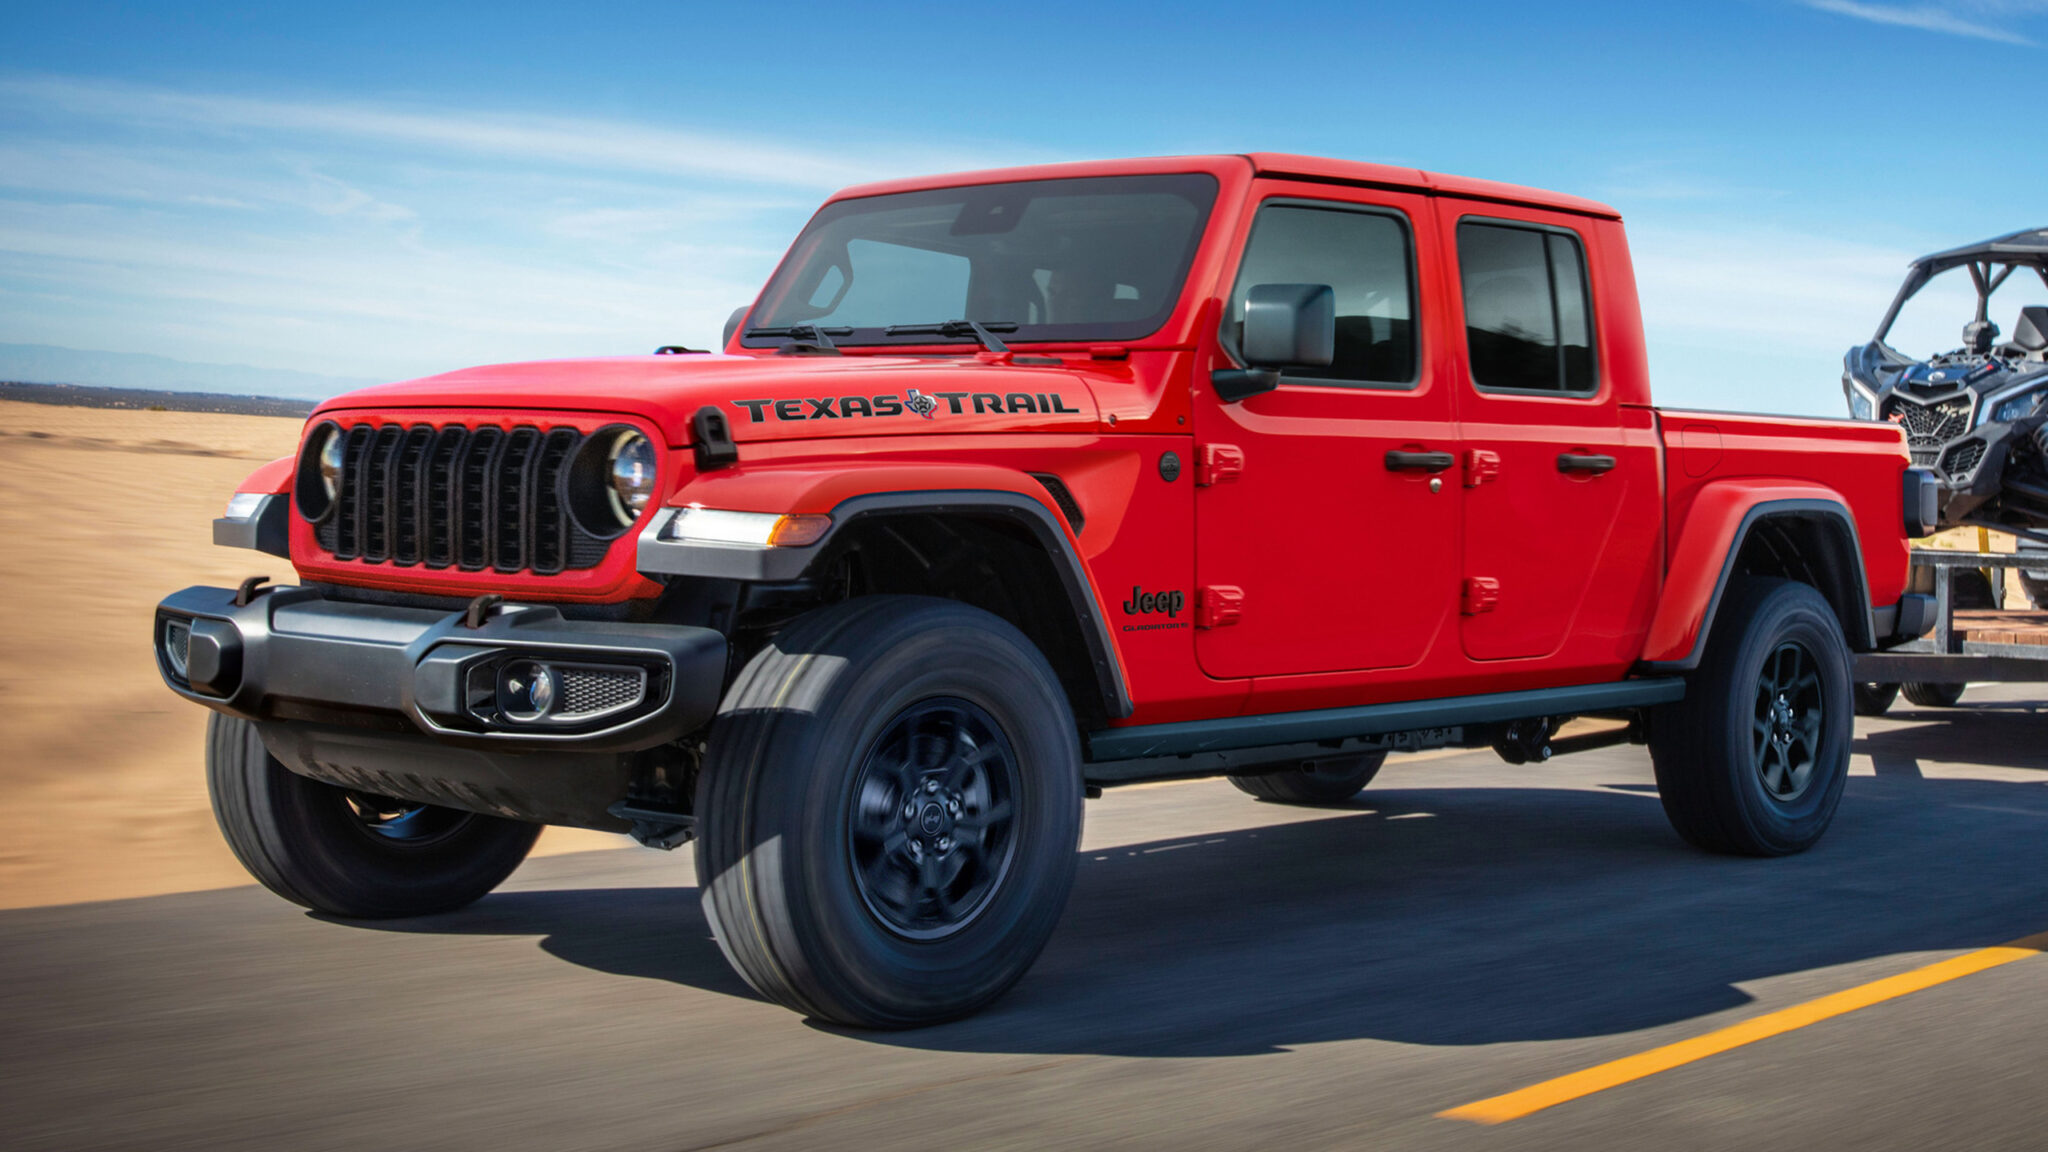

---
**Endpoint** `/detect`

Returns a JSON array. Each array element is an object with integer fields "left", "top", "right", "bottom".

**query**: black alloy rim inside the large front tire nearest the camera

[{"left": 846, "top": 697, "right": 1018, "bottom": 939}]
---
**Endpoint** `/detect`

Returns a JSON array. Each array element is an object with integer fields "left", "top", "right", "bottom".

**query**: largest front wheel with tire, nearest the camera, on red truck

[{"left": 696, "top": 596, "right": 1081, "bottom": 1027}]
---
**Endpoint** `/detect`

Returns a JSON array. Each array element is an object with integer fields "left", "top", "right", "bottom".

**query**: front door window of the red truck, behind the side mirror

[{"left": 1225, "top": 203, "right": 1415, "bottom": 383}]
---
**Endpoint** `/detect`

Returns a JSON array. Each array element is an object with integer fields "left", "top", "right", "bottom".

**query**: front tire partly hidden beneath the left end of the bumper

[{"left": 207, "top": 713, "right": 541, "bottom": 920}]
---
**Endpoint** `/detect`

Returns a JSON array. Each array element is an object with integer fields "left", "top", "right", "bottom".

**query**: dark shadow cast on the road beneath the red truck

[{"left": 348, "top": 748, "right": 2048, "bottom": 1058}]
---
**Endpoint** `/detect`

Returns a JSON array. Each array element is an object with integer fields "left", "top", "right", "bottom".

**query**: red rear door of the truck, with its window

[{"left": 1440, "top": 201, "right": 1659, "bottom": 668}]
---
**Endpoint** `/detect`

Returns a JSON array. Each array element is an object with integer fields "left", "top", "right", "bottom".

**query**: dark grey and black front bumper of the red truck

[{"left": 154, "top": 586, "right": 727, "bottom": 826}]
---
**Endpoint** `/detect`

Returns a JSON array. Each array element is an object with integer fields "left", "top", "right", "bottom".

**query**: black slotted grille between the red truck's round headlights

[{"left": 315, "top": 424, "right": 610, "bottom": 576}]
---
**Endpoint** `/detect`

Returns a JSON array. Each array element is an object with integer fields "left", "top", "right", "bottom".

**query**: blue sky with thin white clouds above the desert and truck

[{"left": 0, "top": 0, "right": 2048, "bottom": 414}]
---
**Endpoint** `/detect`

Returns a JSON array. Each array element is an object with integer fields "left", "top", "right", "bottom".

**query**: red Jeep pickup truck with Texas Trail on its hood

[{"left": 156, "top": 156, "right": 1935, "bottom": 1027}]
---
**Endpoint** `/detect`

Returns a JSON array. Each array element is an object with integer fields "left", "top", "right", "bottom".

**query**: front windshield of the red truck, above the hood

[{"left": 741, "top": 174, "right": 1217, "bottom": 348}]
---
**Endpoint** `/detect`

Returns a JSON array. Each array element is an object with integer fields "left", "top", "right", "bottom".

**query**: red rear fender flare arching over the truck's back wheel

[{"left": 1642, "top": 480, "right": 1876, "bottom": 672}]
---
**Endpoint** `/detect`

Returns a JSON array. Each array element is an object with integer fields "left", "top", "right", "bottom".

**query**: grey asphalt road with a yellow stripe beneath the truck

[{"left": 0, "top": 689, "right": 2048, "bottom": 1152}]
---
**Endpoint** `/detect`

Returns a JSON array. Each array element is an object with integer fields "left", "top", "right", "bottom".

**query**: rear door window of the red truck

[{"left": 1458, "top": 223, "right": 1595, "bottom": 396}]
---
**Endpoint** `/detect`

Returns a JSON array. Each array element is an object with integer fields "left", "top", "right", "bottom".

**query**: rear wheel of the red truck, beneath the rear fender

[{"left": 1651, "top": 578, "right": 1859, "bottom": 857}]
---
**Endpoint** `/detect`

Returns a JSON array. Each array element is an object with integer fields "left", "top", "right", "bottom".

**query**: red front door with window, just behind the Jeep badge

[{"left": 1194, "top": 182, "right": 1460, "bottom": 676}]
